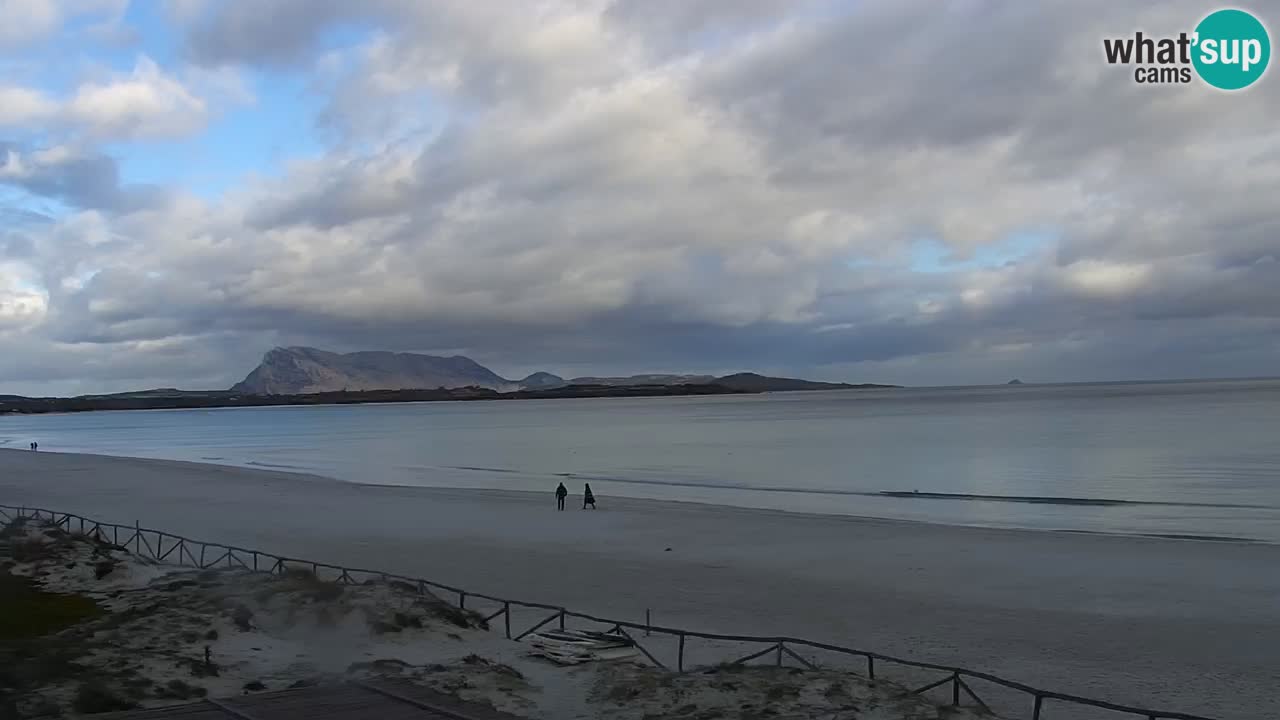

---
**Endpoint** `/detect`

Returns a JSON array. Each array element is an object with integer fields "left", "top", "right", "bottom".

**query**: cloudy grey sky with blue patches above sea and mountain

[{"left": 0, "top": 0, "right": 1280, "bottom": 395}]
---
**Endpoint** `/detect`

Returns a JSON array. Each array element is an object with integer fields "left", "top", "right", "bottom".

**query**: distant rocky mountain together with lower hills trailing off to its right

[{"left": 227, "top": 347, "right": 897, "bottom": 395}]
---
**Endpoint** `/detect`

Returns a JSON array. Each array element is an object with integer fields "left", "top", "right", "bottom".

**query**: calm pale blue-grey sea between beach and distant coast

[{"left": 0, "top": 380, "right": 1280, "bottom": 542}]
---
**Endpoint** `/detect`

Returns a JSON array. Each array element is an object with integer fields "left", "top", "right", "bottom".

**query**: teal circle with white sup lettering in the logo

[{"left": 1192, "top": 10, "right": 1271, "bottom": 90}]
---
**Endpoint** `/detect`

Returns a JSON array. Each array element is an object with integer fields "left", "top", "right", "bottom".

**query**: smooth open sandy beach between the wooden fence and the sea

[{"left": 0, "top": 450, "right": 1280, "bottom": 720}]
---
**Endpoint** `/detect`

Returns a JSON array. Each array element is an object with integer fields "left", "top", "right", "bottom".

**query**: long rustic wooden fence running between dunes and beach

[{"left": 0, "top": 505, "right": 1213, "bottom": 720}]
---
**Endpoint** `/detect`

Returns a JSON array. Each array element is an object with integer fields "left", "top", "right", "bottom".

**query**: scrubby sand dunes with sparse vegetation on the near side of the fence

[{"left": 0, "top": 509, "right": 989, "bottom": 720}]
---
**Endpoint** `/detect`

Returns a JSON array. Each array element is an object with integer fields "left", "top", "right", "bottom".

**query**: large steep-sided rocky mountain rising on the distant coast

[{"left": 232, "top": 347, "right": 524, "bottom": 395}]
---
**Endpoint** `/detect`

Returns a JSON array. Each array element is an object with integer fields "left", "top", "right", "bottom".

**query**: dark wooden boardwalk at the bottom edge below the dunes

[{"left": 95, "top": 682, "right": 522, "bottom": 720}]
